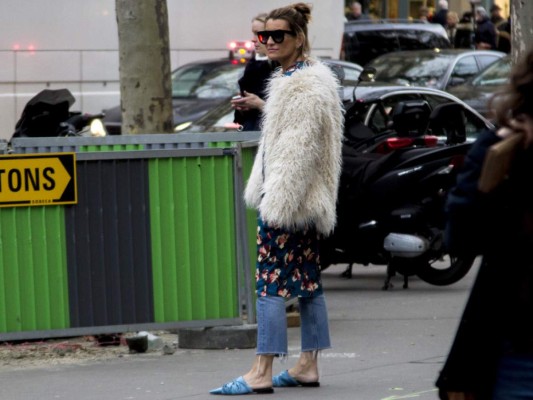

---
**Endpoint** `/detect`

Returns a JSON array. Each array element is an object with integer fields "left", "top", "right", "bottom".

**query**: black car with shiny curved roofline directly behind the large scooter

[{"left": 183, "top": 82, "right": 492, "bottom": 141}]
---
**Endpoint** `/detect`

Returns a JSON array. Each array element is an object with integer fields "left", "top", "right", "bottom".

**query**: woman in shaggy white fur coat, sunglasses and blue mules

[{"left": 210, "top": 3, "right": 343, "bottom": 395}]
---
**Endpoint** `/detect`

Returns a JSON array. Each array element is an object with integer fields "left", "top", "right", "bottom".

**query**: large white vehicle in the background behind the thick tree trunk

[{"left": 0, "top": 0, "right": 344, "bottom": 140}]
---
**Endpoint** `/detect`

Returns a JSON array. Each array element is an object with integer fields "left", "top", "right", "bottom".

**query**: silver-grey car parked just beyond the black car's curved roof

[{"left": 365, "top": 49, "right": 505, "bottom": 90}]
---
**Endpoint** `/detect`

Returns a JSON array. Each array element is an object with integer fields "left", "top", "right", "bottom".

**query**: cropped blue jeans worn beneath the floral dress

[{"left": 256, "top": 294, "right": 331, "bottom": 356}]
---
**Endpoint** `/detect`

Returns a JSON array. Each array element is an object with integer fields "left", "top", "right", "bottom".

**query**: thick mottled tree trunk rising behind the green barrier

[{"left": 115, "top": 0, "right": 173, "bottom": 134}]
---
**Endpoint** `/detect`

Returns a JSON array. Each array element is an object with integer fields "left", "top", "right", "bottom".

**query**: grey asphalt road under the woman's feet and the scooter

[{"left": 0, "top": 265, "right": 477, "bottom": 400}]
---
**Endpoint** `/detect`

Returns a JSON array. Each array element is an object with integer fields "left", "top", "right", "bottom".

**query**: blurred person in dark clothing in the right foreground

[{"left": 436, "top": 47, "right": 533, "bottom": 400}]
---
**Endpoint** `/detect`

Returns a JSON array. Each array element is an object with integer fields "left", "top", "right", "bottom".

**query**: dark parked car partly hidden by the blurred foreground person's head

[{"left": 448, "top": 56, "right": 512, "bottom": 118}]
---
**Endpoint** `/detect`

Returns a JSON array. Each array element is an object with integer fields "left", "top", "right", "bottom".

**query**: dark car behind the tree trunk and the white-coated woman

[{"left": 103, "top": 58, "right": 363, "bottom": 135}]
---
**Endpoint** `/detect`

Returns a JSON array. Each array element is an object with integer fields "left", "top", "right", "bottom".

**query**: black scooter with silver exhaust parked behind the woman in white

[{"left": 321, "top": 100, "right": 474, "bottom": 290}]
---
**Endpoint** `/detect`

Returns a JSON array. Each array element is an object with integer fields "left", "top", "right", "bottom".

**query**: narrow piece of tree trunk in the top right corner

[{"left": 511, "top": 0, "right": 533, "bottom": 64}]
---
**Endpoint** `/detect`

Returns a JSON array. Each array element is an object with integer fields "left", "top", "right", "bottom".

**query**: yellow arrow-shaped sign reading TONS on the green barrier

[{"left": 0, "top": 153, "right": 78, "bottom": 207}]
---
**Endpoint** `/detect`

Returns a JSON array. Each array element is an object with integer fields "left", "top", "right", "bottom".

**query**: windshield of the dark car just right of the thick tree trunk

[{"left": 172, "top": 63, "right": 244, "bottom": 98}]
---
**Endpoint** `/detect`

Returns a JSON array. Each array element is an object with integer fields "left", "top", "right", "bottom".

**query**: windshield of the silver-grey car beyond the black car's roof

[{"left": 368, "top": 53, "right": 454, "bottom": 86}]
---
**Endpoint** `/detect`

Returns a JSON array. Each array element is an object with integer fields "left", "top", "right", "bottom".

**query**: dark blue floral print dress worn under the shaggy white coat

[{"left": 255, "top": 62, "right": 322, "bottom": 298}]
